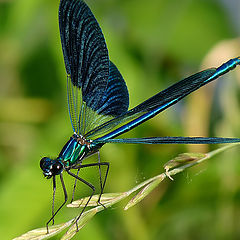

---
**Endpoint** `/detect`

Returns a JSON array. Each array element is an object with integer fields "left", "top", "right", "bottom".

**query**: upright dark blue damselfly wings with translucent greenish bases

[{"left": 59, "top": 0, "right": 128, "bottom": 135}]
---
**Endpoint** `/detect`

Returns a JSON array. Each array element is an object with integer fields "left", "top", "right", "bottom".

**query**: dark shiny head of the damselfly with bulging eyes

[{"left": 40, "top": 157, "right": 64, "bottom": 179}]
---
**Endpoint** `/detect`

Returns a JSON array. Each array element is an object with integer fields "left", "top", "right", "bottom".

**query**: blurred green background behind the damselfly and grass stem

[{"left": 0, "top": 0, "right": 240, "bottom": 240}]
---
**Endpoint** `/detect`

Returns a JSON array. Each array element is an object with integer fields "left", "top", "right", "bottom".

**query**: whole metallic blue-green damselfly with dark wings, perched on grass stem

[{"left": 40, "top": 0, "right": 240, "bottom": 232}]
